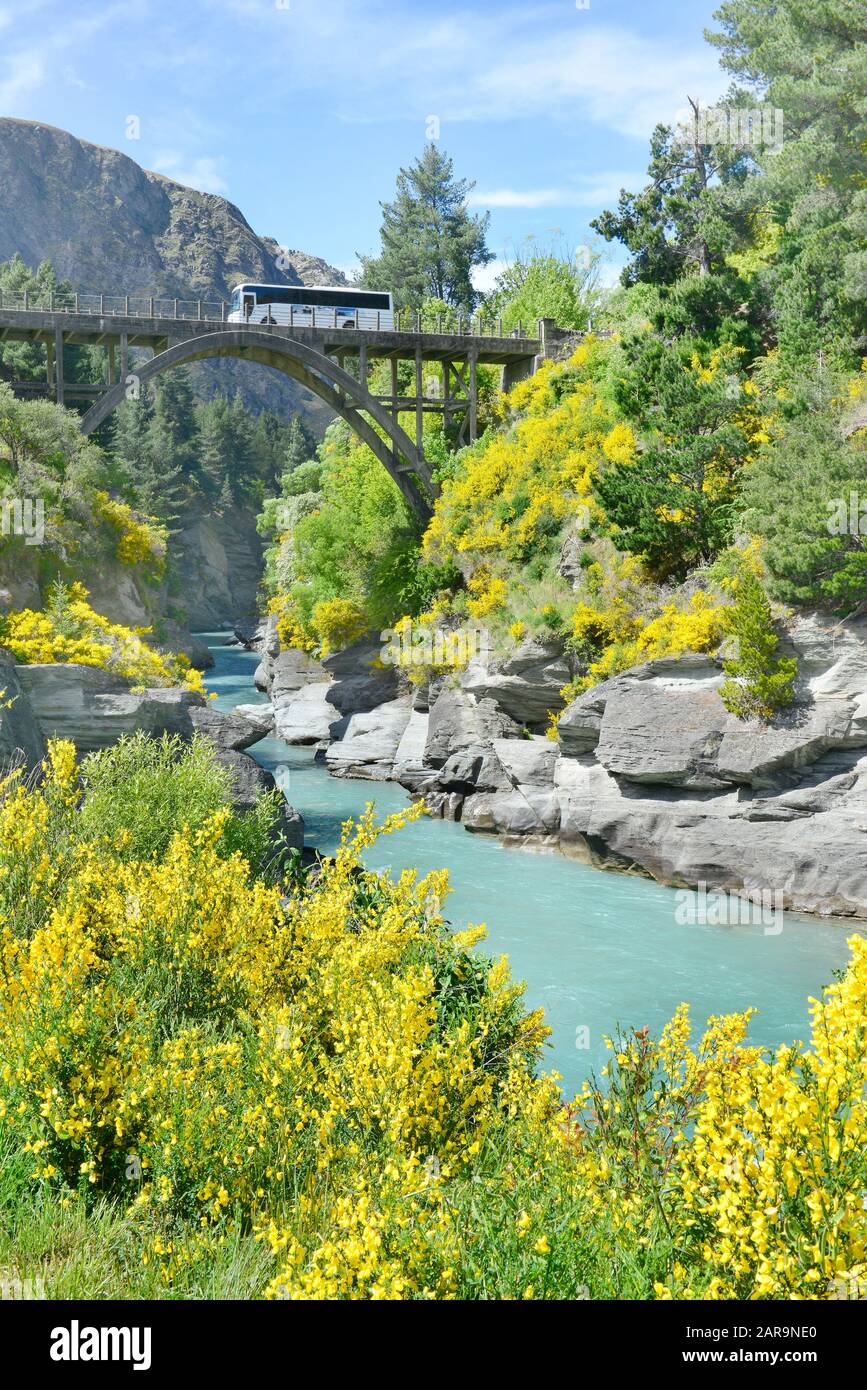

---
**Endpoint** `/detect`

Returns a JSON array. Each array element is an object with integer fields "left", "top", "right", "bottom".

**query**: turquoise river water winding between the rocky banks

[{"left": 199, "top": 632, "right": 853, "bottom": 1095}]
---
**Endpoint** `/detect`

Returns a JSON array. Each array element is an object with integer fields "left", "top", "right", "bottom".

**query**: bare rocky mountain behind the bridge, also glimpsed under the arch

[{"left": 0, "top": 117, "right": 347, "bottom": 432}]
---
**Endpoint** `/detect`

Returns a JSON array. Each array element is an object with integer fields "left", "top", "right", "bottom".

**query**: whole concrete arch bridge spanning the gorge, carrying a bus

[{"left": 0, "top": 295, "right": 582, "bottom": 520}]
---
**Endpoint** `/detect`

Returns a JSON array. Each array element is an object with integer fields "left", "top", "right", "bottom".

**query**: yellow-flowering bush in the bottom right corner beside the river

[{"left": 572, "top": 937, "right": 867, "bottom": 1298}]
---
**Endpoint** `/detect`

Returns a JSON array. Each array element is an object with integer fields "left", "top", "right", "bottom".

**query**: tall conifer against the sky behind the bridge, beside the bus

[{"left": 361, "top": 143, "right": 493, "bottom": 313}]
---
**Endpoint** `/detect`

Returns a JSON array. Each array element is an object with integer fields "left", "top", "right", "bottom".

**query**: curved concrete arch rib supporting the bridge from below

[{"left": 81, "top": 328, "right": 436, "bottom": 520}]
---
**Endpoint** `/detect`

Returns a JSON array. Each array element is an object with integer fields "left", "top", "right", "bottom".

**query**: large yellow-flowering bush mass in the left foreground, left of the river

[{"left": 0, "top": 745, "right": 542, "bottom": 1298}]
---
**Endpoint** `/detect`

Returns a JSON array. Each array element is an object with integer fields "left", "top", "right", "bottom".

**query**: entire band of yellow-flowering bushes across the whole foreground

[{"left": 0, "top": 739, "right": 867, "bottom": 1300}]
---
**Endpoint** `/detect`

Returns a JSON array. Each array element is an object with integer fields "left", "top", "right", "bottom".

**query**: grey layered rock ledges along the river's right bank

[{"left": 248, "top": 614, "right": 867, "bottom": 919}]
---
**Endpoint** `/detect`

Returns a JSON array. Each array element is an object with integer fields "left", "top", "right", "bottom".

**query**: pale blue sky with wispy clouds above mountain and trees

[{"left": 0, "top": 0, "right": 728, "bottom": 278}]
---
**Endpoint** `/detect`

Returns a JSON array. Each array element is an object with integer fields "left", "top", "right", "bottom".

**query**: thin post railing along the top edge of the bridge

[{"left": 0, "top": 289, "right": 538, "bottom": 338}]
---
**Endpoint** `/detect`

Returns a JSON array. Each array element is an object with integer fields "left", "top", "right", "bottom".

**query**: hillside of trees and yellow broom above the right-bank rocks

[{"left": 261, "top": 0, "right": 867, "bottom": 716}]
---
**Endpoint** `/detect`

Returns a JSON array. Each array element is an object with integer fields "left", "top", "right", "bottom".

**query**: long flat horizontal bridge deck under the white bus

[{"left": 0, "top": 309, "right": 542, "bottom": 366}]
